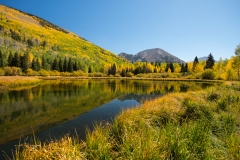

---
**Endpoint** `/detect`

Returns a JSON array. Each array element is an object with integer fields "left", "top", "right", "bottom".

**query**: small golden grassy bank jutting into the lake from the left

[{"left": 0, "top": 76, "right": 42, "bottom": 91}]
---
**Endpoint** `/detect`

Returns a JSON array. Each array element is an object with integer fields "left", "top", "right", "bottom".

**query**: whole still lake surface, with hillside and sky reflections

[{"left": 0, "top": 79, "right": 213, "bottom": 159}]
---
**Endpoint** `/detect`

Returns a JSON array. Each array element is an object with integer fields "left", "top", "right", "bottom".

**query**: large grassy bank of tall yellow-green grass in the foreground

[{"left": 12, "top": 84, "right": 240, "bottom": 159}]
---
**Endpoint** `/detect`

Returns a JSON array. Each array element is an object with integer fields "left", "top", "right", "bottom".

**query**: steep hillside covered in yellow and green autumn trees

[{"left": 0, "top": 5, "right": 129, "bottom": 72}]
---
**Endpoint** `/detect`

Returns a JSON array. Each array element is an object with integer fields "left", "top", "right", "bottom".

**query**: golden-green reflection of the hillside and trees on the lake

[{"left": 0, "top": 79, "right": 215, "bottom": 144}]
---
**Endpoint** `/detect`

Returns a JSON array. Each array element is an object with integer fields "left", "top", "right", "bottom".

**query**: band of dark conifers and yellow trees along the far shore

[{"left": 0, "top": 45, "right": 240, "bottom": 80}]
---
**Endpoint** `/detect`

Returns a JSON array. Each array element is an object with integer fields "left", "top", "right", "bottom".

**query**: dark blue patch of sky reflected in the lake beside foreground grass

[{"left": 37, "top": 99, "right": 140, "bottom": 140}]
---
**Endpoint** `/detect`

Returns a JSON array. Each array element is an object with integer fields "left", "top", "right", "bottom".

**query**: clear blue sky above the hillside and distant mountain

[{"left": 0, "top": 0, "right": 240, "bottom": 61}]
